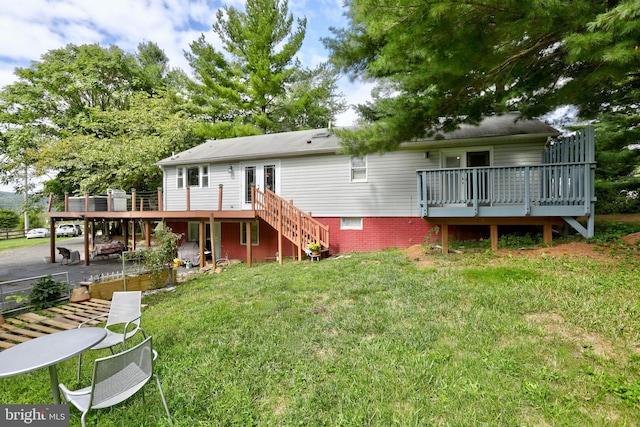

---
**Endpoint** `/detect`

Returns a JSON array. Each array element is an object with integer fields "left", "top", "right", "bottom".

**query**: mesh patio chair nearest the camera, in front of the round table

[{"left": 58, "top": 337, "right": 172, "bottom": 427}]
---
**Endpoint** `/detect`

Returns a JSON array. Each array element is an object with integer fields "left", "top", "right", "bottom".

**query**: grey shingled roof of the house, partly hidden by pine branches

[{"left": 157, "top": 113, "right": 559, "bottom": 166}]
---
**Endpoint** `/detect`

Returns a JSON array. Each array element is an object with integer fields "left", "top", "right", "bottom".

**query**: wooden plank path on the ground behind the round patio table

[{"left": 0, "top": 298, "right": 111, "bottom": 351}]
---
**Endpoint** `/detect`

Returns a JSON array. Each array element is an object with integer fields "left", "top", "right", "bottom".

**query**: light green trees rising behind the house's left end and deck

[{"left": 0, "top": 0, "right": 346, "bottom": 205}]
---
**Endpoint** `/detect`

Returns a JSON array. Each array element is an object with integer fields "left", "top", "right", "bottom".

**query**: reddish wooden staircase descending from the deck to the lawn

[{"left": 251, "top": 187, "right": 329, "bottom": 263}]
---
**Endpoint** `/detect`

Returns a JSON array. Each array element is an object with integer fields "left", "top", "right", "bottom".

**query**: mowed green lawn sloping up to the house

[{"left": 0, "top": 250, "right": 640, "bottom": 426}]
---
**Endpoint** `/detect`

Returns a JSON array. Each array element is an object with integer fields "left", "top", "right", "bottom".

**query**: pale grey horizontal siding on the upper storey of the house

[{"left": 165, "top": 139, "right": 544, "bottom": 218}]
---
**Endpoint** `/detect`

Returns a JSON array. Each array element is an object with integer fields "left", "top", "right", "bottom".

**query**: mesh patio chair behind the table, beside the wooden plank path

[{"left": 78, "top": 291, "right": 146, "bottom": 380}]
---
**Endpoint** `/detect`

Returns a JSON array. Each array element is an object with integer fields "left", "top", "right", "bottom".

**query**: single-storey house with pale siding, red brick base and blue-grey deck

[{"left": 158, "top": 113, "right": 594, "bottom": 260}]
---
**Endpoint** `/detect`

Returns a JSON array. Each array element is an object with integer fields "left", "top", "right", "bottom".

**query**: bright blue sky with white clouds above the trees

[{"left": 0, "top": 0, "right": 372, "bottom": 126}]
